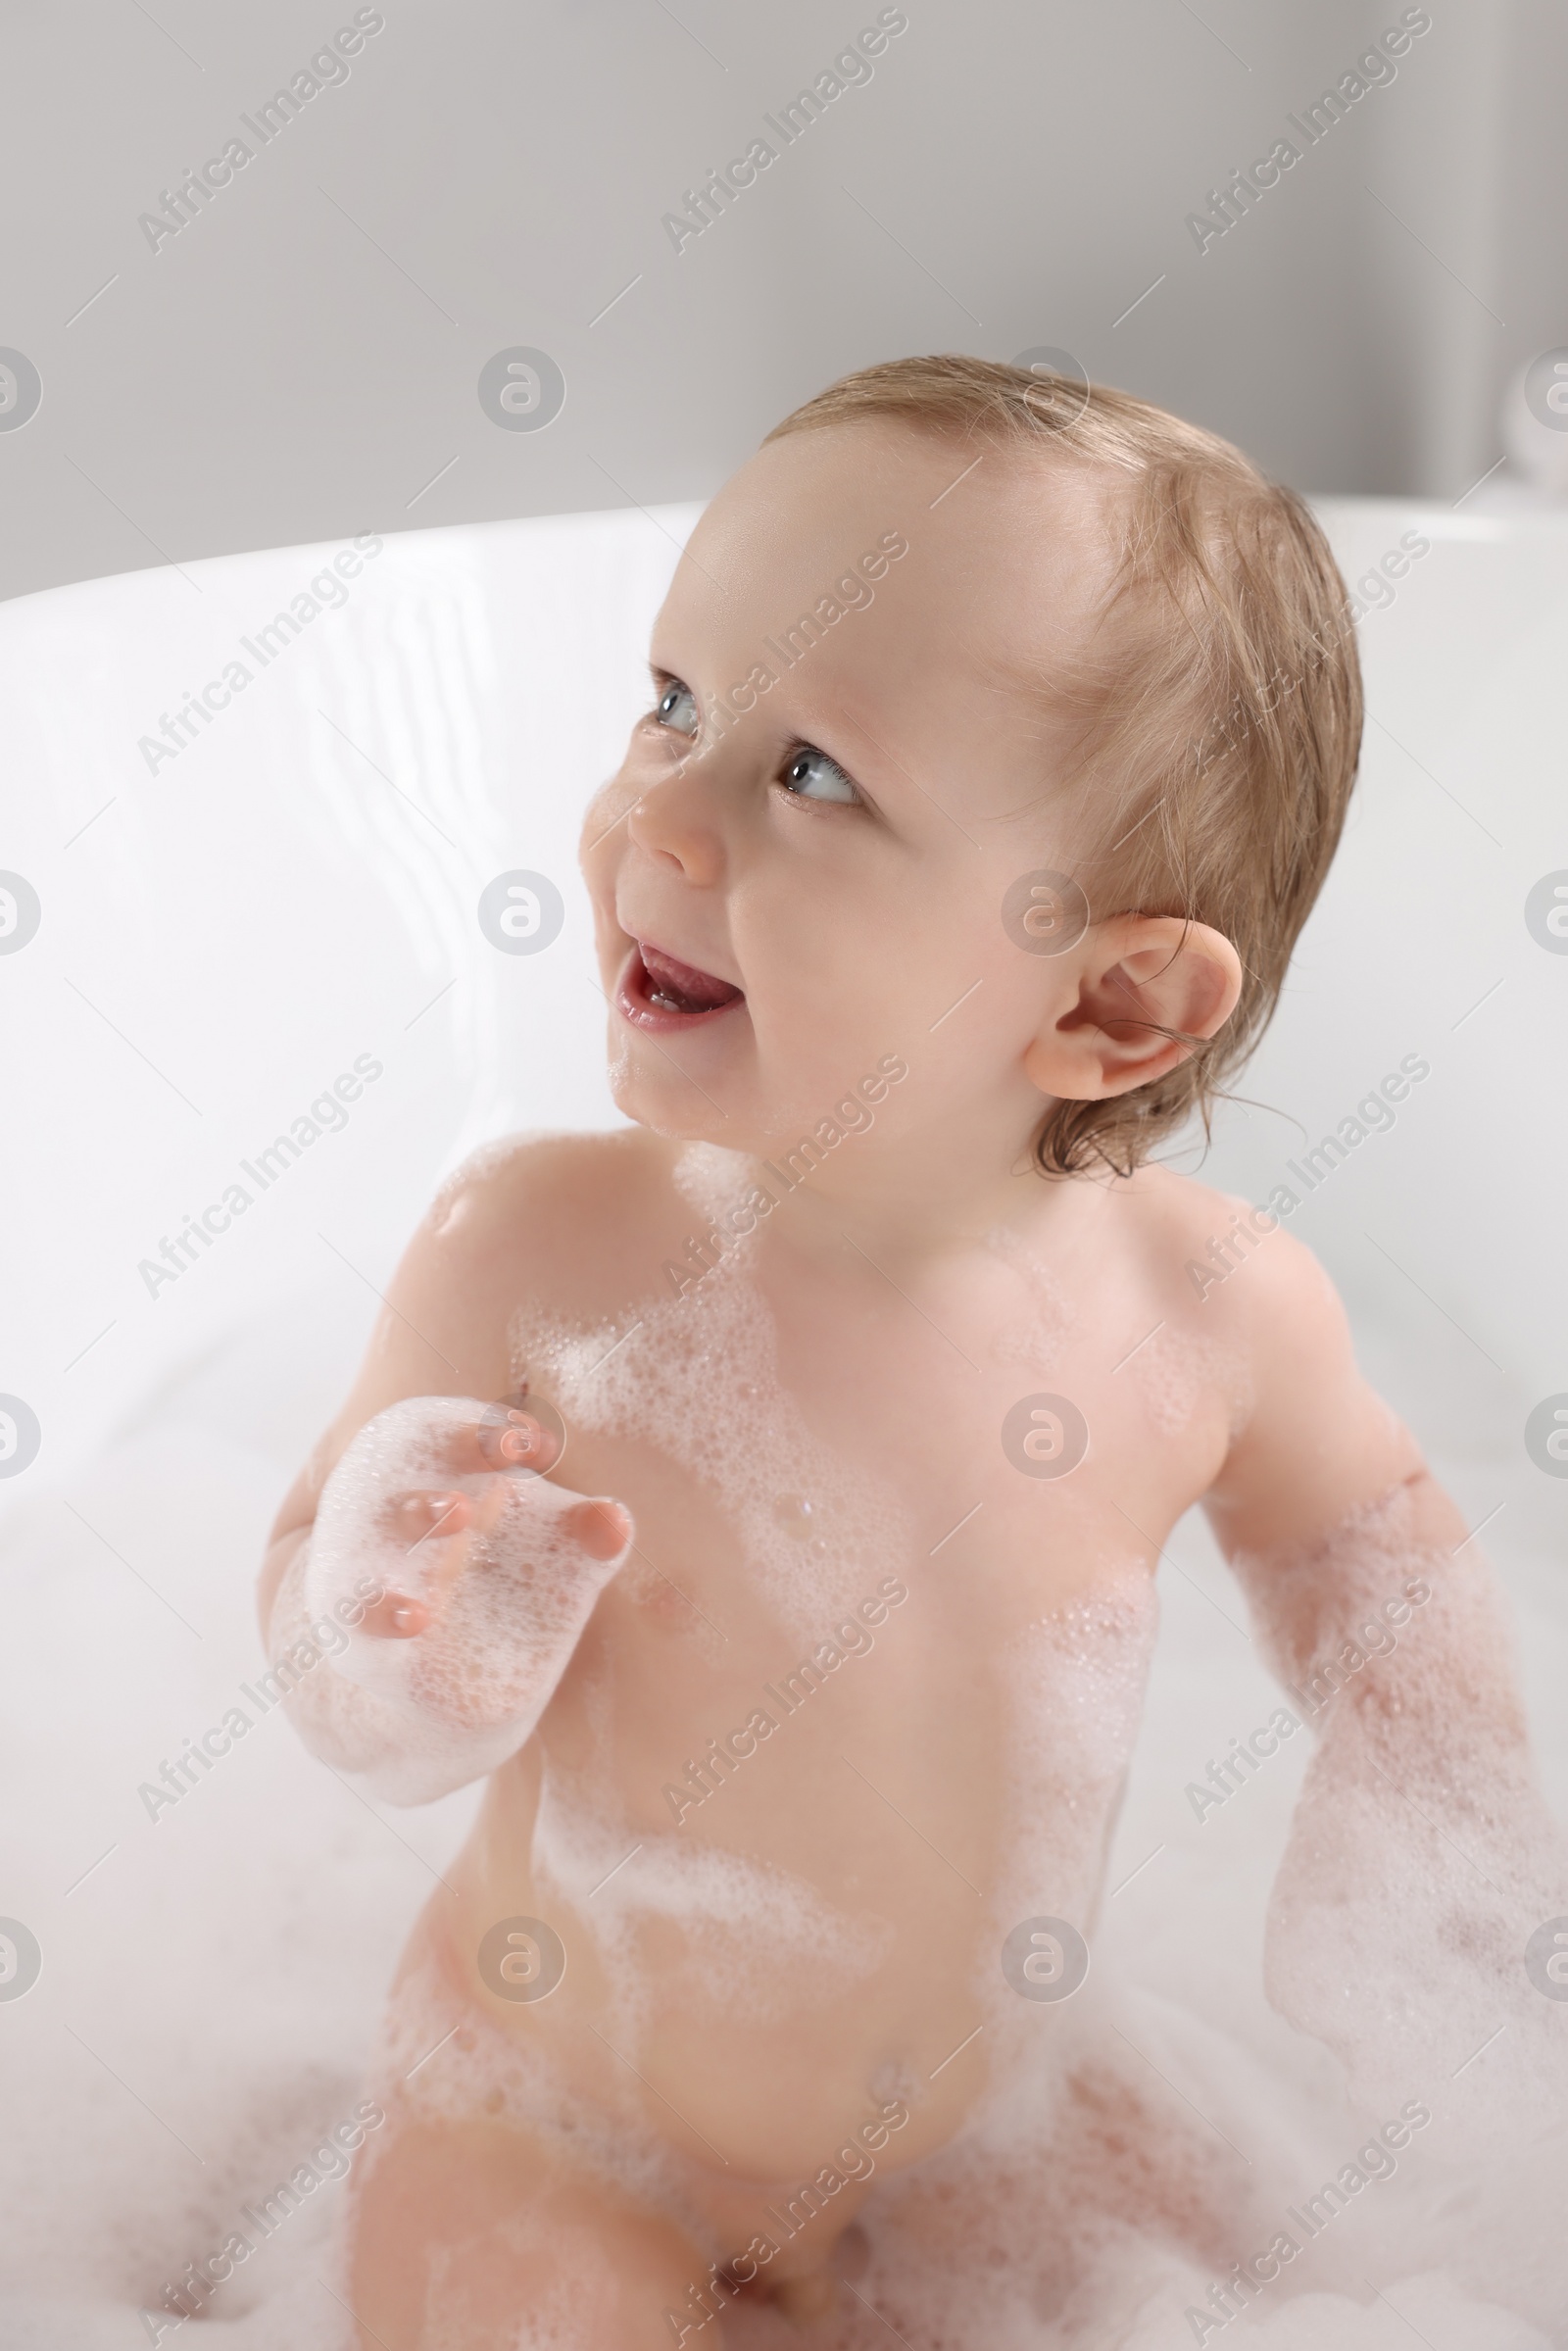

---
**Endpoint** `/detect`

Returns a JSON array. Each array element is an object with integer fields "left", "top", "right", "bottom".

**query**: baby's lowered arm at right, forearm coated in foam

[{"left": 1208, "top": 1232, "right": 1568, "bottom": 2121}]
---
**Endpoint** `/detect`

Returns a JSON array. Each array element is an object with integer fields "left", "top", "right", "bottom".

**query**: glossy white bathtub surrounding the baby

[{"left": 0, "top": 501, "right": 1568, "bottom": 2351}]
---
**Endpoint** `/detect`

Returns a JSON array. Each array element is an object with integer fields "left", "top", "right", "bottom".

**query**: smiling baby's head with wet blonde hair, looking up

[{"left": 583, "top": 358, "right": 1361, "bottom": 1183}]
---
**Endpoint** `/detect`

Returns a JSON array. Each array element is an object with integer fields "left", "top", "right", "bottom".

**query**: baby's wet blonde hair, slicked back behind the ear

[{"left": 768, "top": 353, "right": 1361, "bottom": 1176}]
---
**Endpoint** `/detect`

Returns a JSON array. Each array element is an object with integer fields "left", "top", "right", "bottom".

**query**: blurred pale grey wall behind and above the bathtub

[{"left": 0, "top": 0, "right": 1568, "bottom": 595}]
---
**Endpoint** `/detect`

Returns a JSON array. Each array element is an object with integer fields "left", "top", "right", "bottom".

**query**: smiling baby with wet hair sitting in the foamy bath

[{"left": 261, "top": 358, "right": 1568, "bottom": 2351}]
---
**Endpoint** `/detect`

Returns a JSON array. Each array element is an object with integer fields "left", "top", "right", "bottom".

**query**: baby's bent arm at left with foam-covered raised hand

[{"left": 259, "top": 1156, "right": 630, "bottom": 1803}]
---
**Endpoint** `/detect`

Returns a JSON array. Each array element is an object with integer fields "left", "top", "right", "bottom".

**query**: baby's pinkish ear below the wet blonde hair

[{"left": 1022, "top": 914, "right": 1242, "bottom": 1102}]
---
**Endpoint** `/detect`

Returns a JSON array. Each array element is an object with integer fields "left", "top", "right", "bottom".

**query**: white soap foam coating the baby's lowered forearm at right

[{"left": 1234, "top": 1486, "right": 1568, "bottom": 2141}]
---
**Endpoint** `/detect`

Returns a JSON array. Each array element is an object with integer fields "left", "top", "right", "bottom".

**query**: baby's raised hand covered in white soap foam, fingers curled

[{"left": 306, "top": 1396, "right": 632, "bottom": 1744}]
